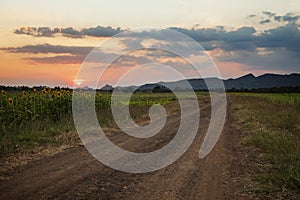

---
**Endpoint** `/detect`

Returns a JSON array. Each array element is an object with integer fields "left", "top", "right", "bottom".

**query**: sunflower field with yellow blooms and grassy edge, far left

[{"left": 0, "top": 87, "right": 110, "bottom": 155}]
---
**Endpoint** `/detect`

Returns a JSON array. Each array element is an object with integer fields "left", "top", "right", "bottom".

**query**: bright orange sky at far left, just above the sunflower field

[{"left": 0, "top": 53, "right": 79, "bottom": 86}]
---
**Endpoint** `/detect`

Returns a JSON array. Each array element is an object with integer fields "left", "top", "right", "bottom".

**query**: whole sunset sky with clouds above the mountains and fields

[{"left": 0, "top": 0, "right": 300, "bottom": 87}]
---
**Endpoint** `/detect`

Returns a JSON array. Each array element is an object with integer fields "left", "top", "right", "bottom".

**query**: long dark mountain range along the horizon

[{"left": 101, "top": 73, "right": 300, "bottom": 92}]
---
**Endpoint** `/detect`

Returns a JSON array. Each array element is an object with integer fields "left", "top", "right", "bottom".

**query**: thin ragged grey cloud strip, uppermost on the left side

[{"left": 14, "top": 26, "right": 123, "bottom": 38}]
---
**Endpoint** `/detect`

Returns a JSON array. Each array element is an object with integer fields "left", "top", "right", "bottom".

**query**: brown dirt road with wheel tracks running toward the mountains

[{"left": 0, "top": 99, "right": 246, "bottom": 199}]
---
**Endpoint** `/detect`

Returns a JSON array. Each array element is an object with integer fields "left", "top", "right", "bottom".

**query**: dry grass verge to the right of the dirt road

[{"left": 231, "top": 93, "right": 300, "bottom": 198}]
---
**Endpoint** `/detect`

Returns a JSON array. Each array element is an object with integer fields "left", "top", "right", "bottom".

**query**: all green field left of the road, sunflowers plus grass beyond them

[{"left": 0, "top": 88, "right": 185, "bottom": 155}]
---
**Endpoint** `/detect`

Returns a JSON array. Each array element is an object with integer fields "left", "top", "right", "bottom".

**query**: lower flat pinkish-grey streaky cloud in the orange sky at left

[{"left": 0, "top": 44, "right": 152, "bottom": 67}]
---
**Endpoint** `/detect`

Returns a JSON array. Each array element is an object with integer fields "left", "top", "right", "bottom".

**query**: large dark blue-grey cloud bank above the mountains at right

[{"left": 166, "top": 21, "right": 300, "bottom": 71}]
